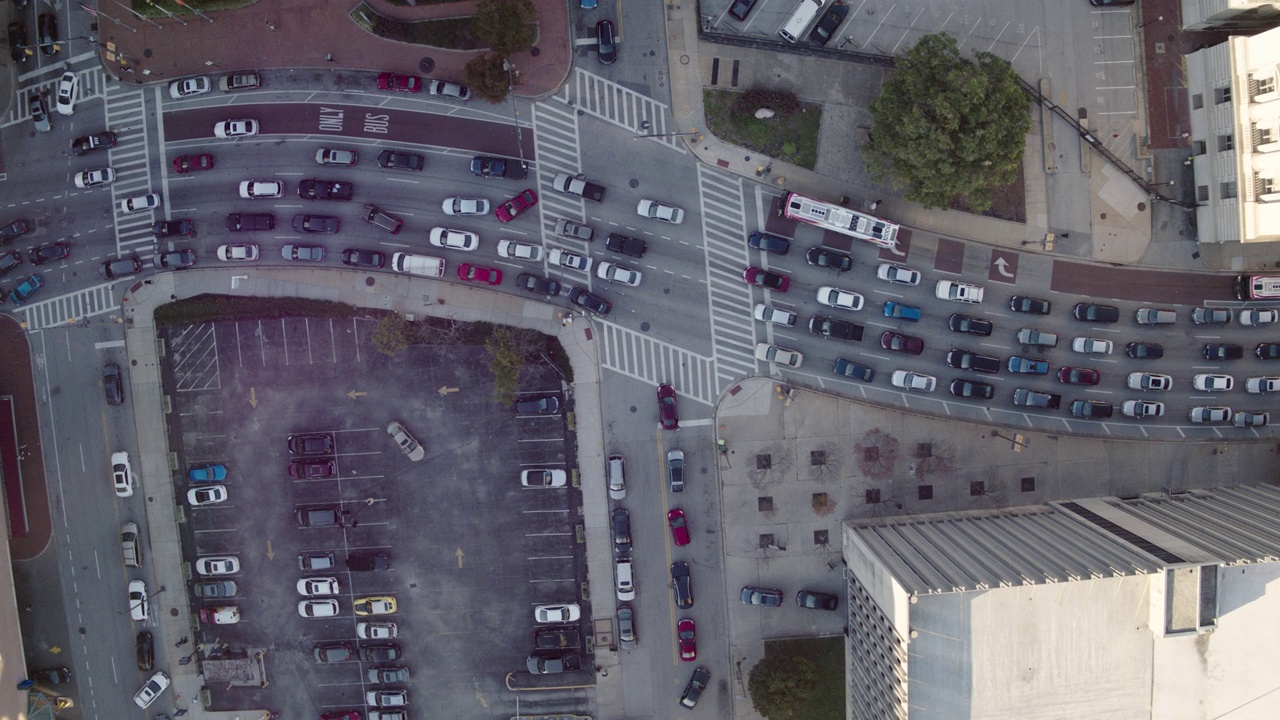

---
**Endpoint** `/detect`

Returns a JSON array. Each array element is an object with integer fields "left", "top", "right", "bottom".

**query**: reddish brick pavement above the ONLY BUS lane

[{"left": 97, "top": 0, "right": 572, "bottom": 97}]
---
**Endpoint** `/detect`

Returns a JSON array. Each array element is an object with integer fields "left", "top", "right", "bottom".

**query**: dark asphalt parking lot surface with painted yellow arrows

[{"left": 163, "top": 318, "right": 590, "bottom": 717}]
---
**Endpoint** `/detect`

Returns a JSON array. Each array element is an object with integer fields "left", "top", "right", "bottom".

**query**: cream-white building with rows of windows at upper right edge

[{"left": 1187, "top": 28, "right": 1280, "bottom": 242}]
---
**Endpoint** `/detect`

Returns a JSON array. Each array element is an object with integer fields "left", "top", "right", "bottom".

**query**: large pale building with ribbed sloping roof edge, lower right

[{"left": 842, "top": 486, "right": 1280, "bottom": 720}]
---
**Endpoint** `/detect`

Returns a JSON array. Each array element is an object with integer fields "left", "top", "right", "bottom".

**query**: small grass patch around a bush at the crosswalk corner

[{"left": 703, "top": 90, "right": 822, "bottom": 170}]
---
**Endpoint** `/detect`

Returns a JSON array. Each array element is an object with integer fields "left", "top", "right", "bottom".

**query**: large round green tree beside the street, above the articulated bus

[{"left": 867, "top": 33, "right": 1030, "bottom": 213}]
